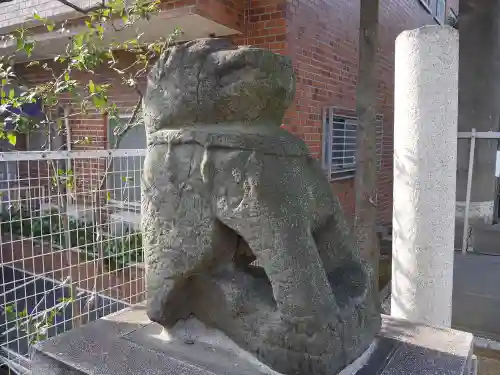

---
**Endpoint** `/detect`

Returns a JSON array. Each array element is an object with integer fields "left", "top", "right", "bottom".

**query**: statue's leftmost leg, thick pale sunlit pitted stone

[{"left": 142, "top": 145, "right": 232, "bottom": 327}]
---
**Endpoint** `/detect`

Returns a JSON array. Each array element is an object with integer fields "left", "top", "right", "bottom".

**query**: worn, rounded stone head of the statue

[{"left": 143, "top": 38, "right": 295, "bottom": 132}]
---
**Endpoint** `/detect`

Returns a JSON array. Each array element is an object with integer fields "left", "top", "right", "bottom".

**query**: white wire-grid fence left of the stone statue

[{"left": 0, "top": 150, "right": 145, "bottom": 373}]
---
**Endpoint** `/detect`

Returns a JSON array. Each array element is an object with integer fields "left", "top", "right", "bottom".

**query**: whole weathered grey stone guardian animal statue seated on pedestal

[{"left": 142, "top": 39, "right": 380, "bottom": 375}]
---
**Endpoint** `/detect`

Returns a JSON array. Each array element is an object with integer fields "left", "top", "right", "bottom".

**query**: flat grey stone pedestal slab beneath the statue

[{"left": 31, "top": 306, "right": 475, "bottom": 375}]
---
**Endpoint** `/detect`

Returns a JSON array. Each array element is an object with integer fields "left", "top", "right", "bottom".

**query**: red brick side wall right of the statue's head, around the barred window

[{"left": 285, "top": 0, "right": 458, "bottom": 224}]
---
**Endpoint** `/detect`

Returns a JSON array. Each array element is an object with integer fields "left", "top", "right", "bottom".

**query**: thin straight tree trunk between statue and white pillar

[{"left": 355, "top": 0, "right": 380, "bottom": 294}]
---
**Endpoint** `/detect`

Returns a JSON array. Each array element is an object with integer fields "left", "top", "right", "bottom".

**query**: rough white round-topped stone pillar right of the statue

[{"left": 391, "top": 26, "right": 458, "bottom": 327}]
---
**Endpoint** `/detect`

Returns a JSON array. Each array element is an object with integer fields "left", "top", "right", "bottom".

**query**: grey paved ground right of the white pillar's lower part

[{"left": 453, "top": 252, "right": 500, "bottom": 340}]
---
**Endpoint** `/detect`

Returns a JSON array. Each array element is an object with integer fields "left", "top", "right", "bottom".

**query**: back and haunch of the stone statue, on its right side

[{"left": 309, "top": 160, "right": 380, "bottom": 359}]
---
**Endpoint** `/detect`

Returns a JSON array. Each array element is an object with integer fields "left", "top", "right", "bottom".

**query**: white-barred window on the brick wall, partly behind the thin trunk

[{"left": 323, "top": 107, "right": 382, "bottom": 181}]
